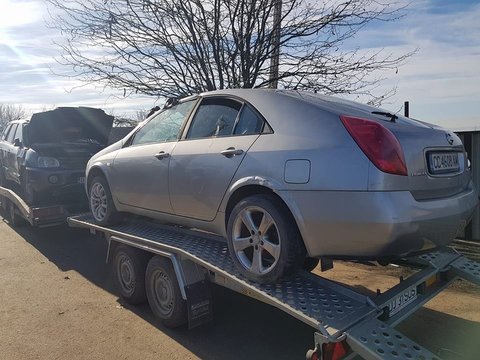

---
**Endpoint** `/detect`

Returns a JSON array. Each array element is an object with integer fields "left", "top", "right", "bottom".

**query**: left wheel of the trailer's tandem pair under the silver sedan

[{"left": 112, "top": 244, "right": 150, "bottom": 305}]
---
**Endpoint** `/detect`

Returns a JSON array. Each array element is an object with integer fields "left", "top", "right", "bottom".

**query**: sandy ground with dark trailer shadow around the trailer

[{"left": 0, "top": 219, "right": 480, "bottom": 360}]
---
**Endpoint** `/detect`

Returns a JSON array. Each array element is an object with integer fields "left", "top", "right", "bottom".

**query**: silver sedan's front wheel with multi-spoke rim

[{"left": 88, "top": 176, "right": 122, "bottom": 225}]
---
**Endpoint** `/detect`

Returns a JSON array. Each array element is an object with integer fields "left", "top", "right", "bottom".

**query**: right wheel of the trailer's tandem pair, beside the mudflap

[{"left": 145, "top": 256, "right": 188, "bottom": 328}]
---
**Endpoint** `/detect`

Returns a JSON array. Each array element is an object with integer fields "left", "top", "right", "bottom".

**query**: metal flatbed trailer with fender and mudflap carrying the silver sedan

[{"left": 68, "top": 214, "right": 480, "bottom": 360}]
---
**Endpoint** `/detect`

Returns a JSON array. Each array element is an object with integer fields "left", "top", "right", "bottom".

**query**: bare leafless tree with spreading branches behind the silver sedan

[{"left": 48, "top": 0, "right": 411, "bottom": 101}]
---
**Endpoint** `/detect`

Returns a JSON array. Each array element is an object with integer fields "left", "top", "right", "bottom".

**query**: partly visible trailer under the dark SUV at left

[{"left": 0, "top": 186, "right": 85, "bottom": 227}]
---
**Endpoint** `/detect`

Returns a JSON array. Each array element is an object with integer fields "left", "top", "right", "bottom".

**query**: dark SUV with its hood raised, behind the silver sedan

[{"left": 0, "top": 107, "right": 113, "bottom": 206}]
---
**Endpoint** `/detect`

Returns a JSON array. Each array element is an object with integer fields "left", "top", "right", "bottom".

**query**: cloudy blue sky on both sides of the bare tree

[{"left": 0, "top": 0, "right": 480, "bottom": 129}]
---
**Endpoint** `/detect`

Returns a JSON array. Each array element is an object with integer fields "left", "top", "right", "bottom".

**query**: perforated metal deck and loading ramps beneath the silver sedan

[{"left": 68, "top": 215, "right": 480, "bottom": 360}]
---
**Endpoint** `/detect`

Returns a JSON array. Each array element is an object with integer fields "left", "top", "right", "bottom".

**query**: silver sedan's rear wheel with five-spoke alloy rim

[{"left": 227, "top": 194, "right": 306, "bottom": 284}]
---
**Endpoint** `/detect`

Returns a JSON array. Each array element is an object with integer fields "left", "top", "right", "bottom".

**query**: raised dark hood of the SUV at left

[{"left": 27, "top": 107, "right": 113, "bottom": 147}]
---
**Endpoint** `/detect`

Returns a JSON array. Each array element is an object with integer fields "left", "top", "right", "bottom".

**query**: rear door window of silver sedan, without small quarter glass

[{"left": 187, "top": 98, "right": 242, "bottom": 139}]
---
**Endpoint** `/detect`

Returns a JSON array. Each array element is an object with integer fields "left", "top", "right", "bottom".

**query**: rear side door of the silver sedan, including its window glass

[{"left": 169, "top": 97, "right": 264, "bottom": 221}]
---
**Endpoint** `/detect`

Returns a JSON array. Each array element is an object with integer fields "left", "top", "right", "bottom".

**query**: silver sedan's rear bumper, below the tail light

[{"left": 278, "top": 182, "right": 478, "bottom": 258}]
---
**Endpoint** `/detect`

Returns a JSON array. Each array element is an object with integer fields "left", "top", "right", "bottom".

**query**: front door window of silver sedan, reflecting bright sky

[{"left": 131, "top": 100, "right": 195, "bottom": 145}]
